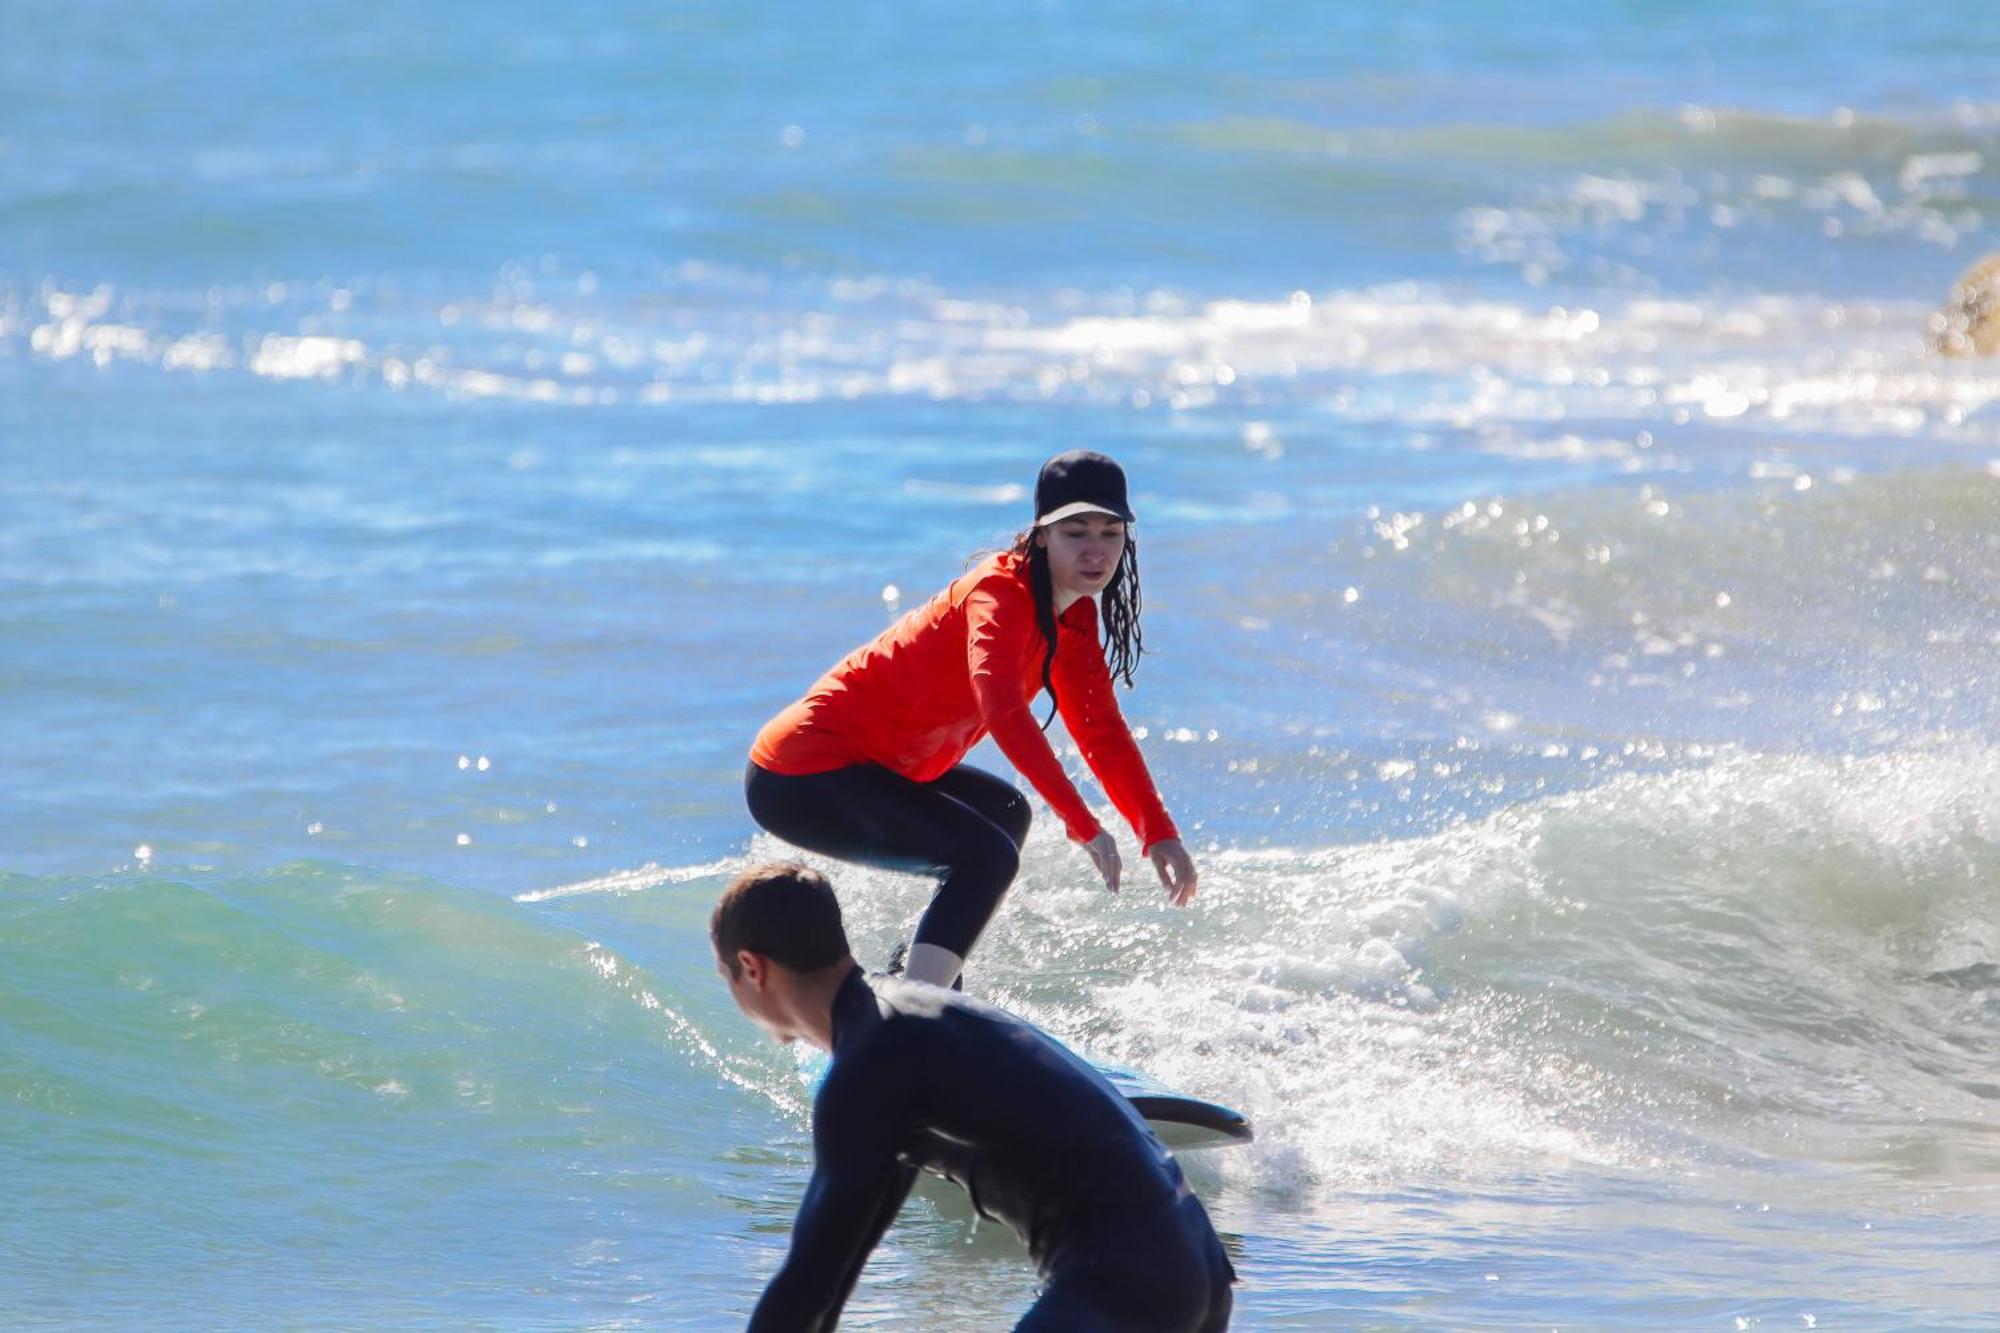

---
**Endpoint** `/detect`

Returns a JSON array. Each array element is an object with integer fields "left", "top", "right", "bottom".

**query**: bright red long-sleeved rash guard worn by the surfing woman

[{"left": 750, "top": 552, "right": 1180, "bottom": 851}]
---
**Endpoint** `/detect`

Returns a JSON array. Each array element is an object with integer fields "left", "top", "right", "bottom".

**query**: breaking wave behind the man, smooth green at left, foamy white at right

[{"left": 15, "top": 743, "right": 2000, "bottom": 1325}]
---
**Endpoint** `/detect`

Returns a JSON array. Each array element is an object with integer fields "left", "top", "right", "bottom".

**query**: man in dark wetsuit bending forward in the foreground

[{"left": 708, "top": 865, "right": 1236, "bottom": 1333}]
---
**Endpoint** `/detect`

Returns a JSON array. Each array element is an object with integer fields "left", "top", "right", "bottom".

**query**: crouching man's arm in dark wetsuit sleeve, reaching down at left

[{"left": 750, "top": 1067, "right": 916, "bottom": 1333}]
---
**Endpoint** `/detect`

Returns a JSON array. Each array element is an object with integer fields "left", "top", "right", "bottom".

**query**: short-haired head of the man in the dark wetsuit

[{"left": 708, "top": 863, "right": 852, "bottom": 1045}]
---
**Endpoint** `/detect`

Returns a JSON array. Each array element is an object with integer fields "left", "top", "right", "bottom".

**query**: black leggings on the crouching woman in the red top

[{"left": 744, "top": 765, "right": 1032, "bottom": 959}]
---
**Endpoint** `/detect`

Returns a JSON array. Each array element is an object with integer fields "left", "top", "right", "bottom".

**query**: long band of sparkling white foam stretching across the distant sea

[{"left": 19, "top": 276, "right": 2000, "bottom": 446}]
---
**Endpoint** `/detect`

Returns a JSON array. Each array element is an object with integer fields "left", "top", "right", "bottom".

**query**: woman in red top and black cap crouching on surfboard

[{"left": 744, "top": 450, "right": 1196, "bottom": 987}]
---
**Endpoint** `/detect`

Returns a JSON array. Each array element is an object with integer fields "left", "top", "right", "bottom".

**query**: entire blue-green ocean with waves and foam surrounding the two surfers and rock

[{"left": 0, "top": 0, "right": 2000, "bottom": 1329}]
